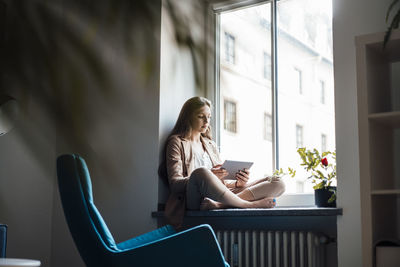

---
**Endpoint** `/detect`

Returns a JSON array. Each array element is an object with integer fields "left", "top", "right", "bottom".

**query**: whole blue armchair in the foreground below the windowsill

[{"left": 57, "top": 154, "right": 229, "bottom": 267}]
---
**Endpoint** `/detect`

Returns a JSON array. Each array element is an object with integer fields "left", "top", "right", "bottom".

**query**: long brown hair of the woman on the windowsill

[{"left": 167, "top": 96, "right": 212, "bottom": 140}]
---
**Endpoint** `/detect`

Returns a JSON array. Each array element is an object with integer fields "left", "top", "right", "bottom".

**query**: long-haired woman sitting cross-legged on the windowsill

[{"left": 161, "top": 97, "right": 285, "bottom": 227}]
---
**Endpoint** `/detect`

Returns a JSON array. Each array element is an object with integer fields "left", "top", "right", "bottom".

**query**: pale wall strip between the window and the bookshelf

[{"left": 333, "top": 0, "right": 392, "bottom": 267}]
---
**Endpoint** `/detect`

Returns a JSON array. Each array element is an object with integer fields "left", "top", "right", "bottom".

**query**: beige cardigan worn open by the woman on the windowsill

[{"left": 165, "top": 135, "right": 222, "bottom": 228}]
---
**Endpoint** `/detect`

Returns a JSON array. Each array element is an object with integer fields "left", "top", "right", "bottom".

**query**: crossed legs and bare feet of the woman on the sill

[{"left": 186, "top": 168, "right": 285, "bottom": 210}]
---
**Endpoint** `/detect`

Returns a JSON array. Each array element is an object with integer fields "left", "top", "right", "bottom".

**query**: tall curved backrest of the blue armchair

[{"left": 57, "top": 154, "right": 117, "bottom": 266}]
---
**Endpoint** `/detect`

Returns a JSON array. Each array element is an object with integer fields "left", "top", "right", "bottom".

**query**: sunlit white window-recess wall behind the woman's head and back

[{"left": 159, "top": 0, "right": 205, "bottom": 203}]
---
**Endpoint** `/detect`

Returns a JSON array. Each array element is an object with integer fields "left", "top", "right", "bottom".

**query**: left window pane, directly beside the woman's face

[{"left": 219, "top": 4, "right": 273, "bottom": 178}]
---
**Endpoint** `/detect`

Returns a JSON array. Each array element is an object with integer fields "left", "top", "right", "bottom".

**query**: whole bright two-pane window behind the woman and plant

[{"left": 216, "top": 0, "right": 335, "bottom": 197}]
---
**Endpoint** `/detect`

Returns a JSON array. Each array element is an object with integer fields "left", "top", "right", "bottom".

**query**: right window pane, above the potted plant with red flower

[{"left": 277, "top": 0, "right": 335, "bottom": 193}]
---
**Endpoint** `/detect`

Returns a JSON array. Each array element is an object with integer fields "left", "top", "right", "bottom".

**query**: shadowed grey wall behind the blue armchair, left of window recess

[{"left": 0, "top": 0, "right": 161, "bottom": 267}]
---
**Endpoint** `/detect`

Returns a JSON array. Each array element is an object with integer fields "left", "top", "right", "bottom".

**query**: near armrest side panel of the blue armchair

[{"left": 113, "top": 225, "right": 229, "bottom": 267}]
